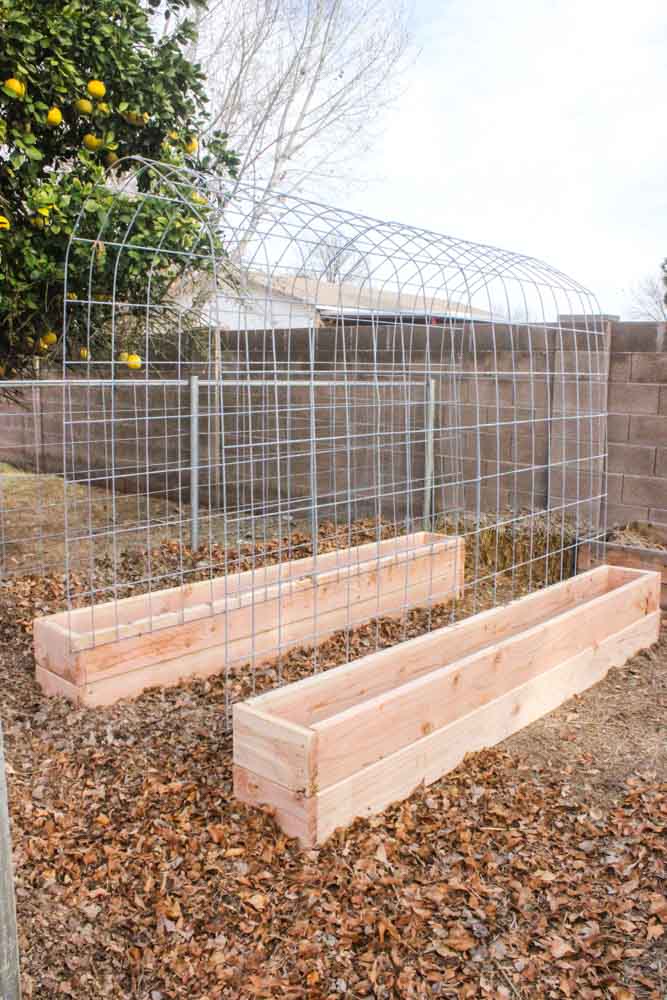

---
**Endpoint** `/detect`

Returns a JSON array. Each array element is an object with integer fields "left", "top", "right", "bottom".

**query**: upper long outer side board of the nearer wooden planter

[{"left": 312, "top": 574, "right": 659, "bottom": 790}]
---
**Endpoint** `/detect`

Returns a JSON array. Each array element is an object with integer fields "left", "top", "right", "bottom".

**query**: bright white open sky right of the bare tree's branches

[{"left": 346, "top": 0, "right": 667, "bottom": 315}]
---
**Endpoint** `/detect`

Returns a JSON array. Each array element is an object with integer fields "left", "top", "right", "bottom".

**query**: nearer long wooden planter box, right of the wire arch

[{"left": 234, "top": 566, "right": 660, "bottom": 846}]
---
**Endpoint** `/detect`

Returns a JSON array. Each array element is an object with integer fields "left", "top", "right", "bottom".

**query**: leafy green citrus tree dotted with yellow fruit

[{"left": 0, "top": 0, "right": 237, "bottom": 376}]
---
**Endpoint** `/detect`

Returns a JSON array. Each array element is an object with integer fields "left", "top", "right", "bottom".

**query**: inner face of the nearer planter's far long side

[{"left": 249, "top": 566, "right": 608, "bottom": 725}]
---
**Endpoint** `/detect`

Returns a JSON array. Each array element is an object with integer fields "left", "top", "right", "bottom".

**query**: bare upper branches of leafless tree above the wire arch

[{"left": 190, "top": 0, "right": 413, "bottom": 194}]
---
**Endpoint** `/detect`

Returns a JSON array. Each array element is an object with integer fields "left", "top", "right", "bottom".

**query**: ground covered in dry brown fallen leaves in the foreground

[{"left": 0, "top": 548, "right": 667, "bottom": 1000}]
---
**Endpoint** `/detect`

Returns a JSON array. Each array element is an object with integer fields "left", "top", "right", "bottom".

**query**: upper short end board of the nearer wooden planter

[{"left": 234, "top": 703, "right": 317, "bottom": 795}]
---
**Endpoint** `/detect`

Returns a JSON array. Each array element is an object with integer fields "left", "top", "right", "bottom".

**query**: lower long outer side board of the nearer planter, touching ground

[{"left": 316, "top": 612, "right": 660, "bottom": 845}]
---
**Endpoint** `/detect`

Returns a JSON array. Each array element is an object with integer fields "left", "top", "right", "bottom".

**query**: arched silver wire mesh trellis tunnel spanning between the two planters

[{"left": 41, "top": 160, "right": 606, "bottom": 705}]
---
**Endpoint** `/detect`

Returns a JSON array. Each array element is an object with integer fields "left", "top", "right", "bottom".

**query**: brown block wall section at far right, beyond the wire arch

[{"left": 607, "top": 322, "right": 667, "bottom": 526}]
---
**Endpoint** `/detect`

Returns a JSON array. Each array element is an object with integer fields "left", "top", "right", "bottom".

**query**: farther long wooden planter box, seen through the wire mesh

[{"left": 34, "top": 532, "right": 465, "bottom": 705}]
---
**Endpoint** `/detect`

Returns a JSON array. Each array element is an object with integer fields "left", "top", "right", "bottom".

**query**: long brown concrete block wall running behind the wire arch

[{"left": 0, "top": 321, "right": 667, "bottom": 540}]
